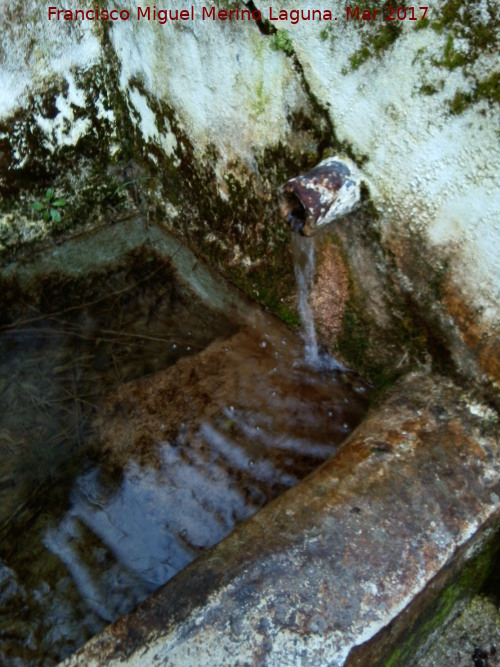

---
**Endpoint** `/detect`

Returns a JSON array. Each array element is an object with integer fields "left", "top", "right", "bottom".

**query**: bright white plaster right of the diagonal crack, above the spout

[{"left": 257, "top": 0, "right": 500, "bottom": 328}]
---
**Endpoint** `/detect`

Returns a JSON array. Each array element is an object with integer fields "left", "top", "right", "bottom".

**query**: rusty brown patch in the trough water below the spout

[{"left": 95, "top": 323, "right": 369, "bottom": 472}]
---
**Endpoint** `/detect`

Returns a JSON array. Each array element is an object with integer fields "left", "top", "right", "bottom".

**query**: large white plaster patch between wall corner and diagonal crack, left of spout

[{"left": 111, "top": 0, "right": 306, "bottom": 166}]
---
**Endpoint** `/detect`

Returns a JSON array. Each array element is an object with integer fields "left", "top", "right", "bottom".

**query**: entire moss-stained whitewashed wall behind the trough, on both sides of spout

[{"left": 0, "top": 0, "right": 500, "bottom": 394}]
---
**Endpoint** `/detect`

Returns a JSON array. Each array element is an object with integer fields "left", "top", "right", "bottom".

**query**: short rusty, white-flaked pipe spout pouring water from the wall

[{"left": 279, "top": 157, "right": 361, "bottom": 236}]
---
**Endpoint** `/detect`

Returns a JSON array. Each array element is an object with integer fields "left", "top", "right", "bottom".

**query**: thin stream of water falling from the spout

[{"left": 292, "top": 234, "right": 320, "bottom": 368}]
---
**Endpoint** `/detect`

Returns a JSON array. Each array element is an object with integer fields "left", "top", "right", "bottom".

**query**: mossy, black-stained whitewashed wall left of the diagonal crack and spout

[{"left": 0, "top": 2, "right": 335, "bottom": 319}]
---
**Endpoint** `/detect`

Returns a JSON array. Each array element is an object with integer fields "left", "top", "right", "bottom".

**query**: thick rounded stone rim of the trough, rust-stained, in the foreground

[{"left": 60, "top": 376, "right": 500, "bottom": 667}]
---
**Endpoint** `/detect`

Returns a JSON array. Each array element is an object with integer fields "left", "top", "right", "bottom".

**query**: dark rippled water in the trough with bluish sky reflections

[{"left": 0, "top": 222, "right": 369, "bottom": 666}]
